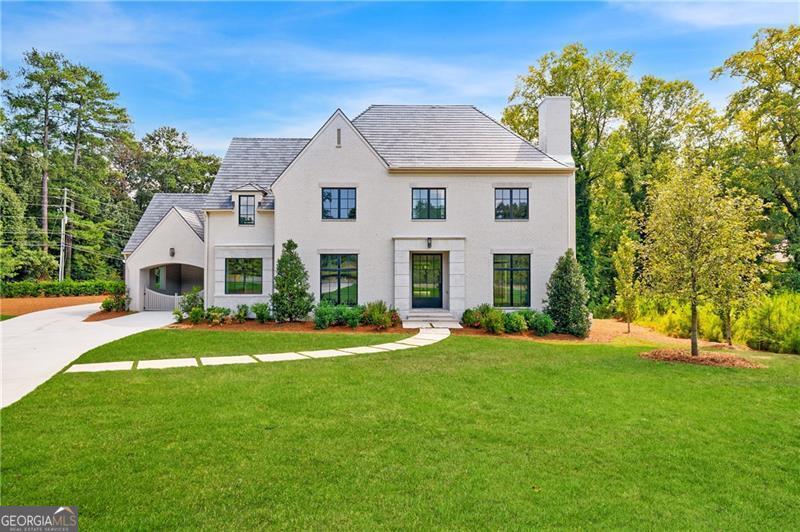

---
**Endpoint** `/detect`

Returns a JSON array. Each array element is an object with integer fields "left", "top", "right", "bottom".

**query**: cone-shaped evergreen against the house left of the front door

[{"left": 272, "top": 240, "right": 314, "bottom": 321}]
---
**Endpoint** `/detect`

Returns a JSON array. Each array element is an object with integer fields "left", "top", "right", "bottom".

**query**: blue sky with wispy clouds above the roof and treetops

[{"left": 1, "top": 2, "right": 800, "bottom": 154}]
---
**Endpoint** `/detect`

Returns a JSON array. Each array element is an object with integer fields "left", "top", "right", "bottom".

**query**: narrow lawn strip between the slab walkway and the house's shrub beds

[{"left": 75, "top": 329, "right": 412, "bottom": 364}]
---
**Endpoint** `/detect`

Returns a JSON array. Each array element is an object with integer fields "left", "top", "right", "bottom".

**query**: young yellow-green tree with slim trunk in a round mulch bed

[{"left": 646, "top": 173, "right": 761, "bottom": 356}]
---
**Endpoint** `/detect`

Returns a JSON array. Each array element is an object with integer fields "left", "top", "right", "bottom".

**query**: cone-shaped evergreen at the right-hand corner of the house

[{"left": 544, "top": 249, "right": 591, "bottom": 338}]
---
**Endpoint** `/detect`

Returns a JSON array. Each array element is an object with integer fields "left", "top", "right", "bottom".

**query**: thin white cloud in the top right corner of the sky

[{"left": 613, "top": 1, "right": 800, "bottom": 29}]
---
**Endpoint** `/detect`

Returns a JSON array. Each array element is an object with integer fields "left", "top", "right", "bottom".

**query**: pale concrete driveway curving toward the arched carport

[{"left": 0, "top": 303, "right": 174, "bottom": 407}]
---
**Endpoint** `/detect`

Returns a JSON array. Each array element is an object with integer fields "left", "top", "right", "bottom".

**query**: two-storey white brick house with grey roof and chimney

[{"left": 123, "top": 97, "right": 575, "bottom": 318}]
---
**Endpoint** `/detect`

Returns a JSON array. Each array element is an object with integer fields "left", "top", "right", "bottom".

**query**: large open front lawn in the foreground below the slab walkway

[{"left": 0, "top": 331, "right": 800, "bottom": 530}]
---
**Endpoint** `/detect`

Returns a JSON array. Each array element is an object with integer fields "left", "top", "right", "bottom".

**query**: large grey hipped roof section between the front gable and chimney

[{"left": 353, "top": 105, "right": 571, "bottom": 170}]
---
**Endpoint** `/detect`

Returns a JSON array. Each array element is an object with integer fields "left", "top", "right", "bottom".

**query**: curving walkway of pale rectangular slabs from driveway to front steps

[{"left": 66, "top": 327, "right": 450, "bottom": 373}]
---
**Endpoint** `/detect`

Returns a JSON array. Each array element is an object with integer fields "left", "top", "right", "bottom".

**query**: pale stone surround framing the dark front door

[{"left": 392, "top": 236, "right": 466, "bottom": 318}]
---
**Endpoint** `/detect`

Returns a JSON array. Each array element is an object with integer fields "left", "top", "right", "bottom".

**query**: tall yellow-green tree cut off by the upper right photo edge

[{"left": 713, "top": 25, "right": 800, "bottom": 270}]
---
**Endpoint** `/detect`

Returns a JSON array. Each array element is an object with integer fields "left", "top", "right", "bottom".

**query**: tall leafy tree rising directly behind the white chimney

[{"left": 503, "top": 43, "right": 634, "bottom": 298}]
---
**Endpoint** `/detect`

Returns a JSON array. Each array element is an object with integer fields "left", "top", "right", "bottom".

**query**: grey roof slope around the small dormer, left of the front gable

[{"left": 205, "top": 137, "right": 309, "bottom": 209}]
